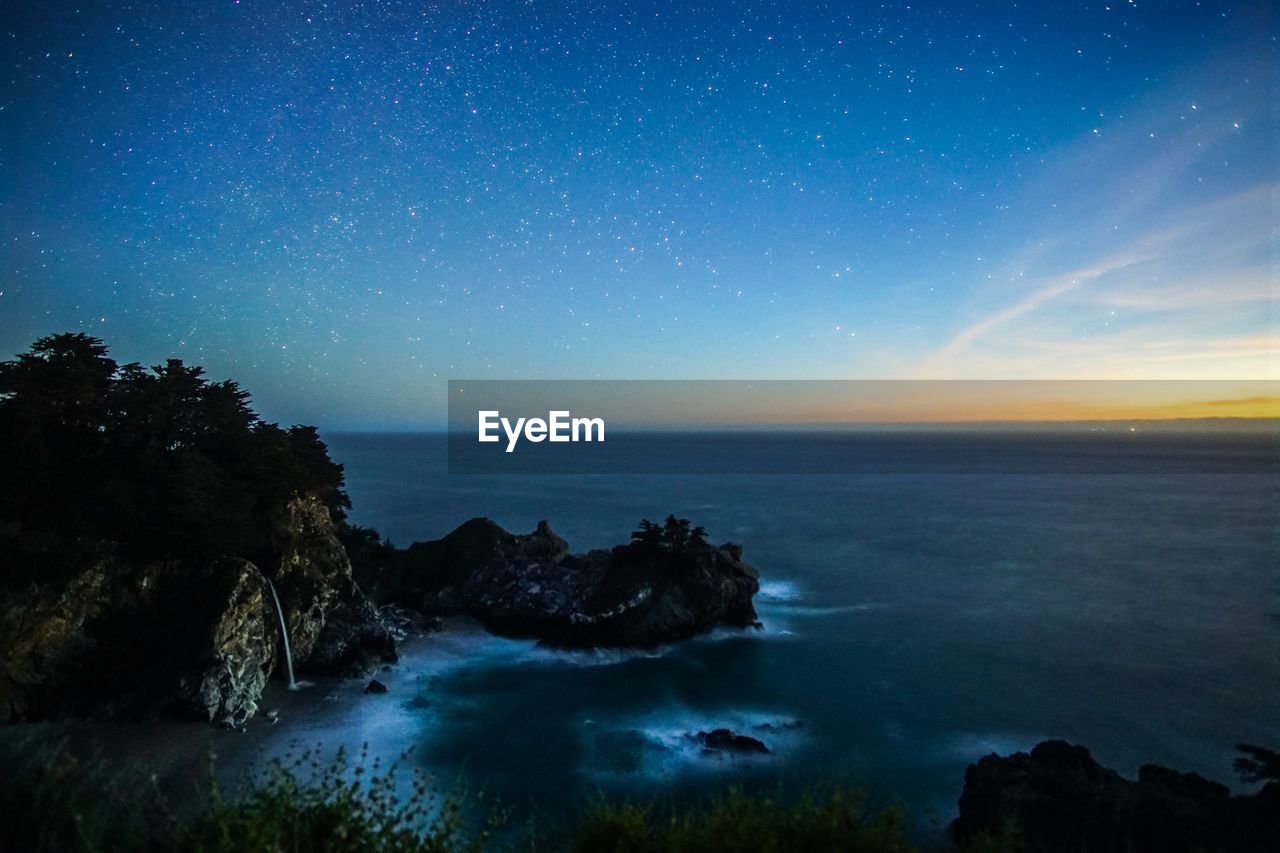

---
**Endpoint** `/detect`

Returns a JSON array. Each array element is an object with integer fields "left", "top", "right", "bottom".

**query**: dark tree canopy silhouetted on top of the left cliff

[{"left": 0, "top": 333, "right": 349, "bottom": 581}]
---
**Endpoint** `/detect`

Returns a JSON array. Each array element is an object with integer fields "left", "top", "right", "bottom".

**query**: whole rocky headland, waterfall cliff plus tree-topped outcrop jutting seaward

[{"left": 0, "top": 497, "right": 759, "bottom": 726}]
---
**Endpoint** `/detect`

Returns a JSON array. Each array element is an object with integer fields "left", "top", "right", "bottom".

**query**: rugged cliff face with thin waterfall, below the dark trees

[{"left": 0, "top": 497, "right": 403, "bottom": 725}]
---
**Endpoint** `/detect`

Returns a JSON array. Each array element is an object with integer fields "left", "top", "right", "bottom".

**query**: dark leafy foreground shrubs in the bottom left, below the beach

[{"left": 0, "top": 738, "right": 503, "bottom": 853}]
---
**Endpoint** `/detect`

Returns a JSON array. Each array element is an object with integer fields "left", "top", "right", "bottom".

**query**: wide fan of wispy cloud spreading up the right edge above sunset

[{"left": 908, "top": 24, "right": 1280, "bottom": 377}]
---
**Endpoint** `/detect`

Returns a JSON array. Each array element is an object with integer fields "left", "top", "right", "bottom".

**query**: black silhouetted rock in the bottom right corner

[{"left": 951, "top": 740, "right": 1280, "bottom": 853}]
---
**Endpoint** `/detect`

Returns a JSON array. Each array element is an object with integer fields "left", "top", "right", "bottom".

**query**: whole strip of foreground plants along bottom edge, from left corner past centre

[{"left": 0, "top": 736, "right": 998, "bottom": 853}]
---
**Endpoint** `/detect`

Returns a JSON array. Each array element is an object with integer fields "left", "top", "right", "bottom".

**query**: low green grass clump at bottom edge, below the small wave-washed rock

[{"left": 570, "top": 788, "right": 914, "bottom": 853}]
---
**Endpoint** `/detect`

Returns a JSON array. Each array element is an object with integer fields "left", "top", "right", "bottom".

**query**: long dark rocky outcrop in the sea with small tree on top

[{"left": 380, "top": 519, "right": 760, "bottom": 647}]
